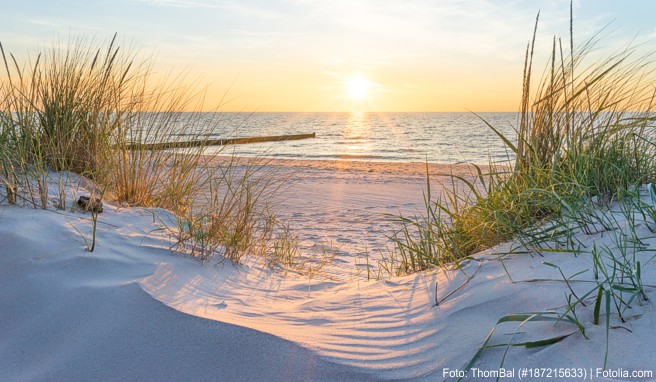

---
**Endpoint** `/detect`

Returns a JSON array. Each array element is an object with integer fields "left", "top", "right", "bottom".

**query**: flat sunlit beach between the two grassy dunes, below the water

[{"left": 210, "top": 158, "right": 488, "bottom": 279}]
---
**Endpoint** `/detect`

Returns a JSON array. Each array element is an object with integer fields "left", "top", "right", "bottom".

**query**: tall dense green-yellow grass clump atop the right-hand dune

[{"left": 391, "top": 7, "right": 656, "bottom": 273}]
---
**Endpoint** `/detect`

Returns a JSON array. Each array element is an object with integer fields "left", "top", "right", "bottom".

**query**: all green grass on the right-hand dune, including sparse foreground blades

[{"left": 376, "top": 5, "right": 656, "bottom": 376}]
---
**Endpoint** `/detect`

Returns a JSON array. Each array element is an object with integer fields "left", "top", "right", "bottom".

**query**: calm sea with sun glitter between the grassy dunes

[{"left": 193, "top": 112, "right": 517, "bottom": 164}]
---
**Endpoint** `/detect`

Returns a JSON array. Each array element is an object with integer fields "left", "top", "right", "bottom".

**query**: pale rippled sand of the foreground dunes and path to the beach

[{"left": 0, "top": 160, "right": 656, "bottom": 381}]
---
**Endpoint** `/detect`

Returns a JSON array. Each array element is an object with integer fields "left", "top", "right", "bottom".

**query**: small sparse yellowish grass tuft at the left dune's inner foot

[{"left": 173, "top": 157, "right": 290, "bottom": 266}]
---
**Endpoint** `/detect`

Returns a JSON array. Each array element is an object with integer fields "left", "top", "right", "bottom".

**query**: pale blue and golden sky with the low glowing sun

[{"left": 0, "top": 0, "right": 656, "bottom": 112}]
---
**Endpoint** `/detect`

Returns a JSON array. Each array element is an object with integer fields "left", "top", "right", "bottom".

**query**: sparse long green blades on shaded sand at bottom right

[{"left": 464, "top": 188, "right": 656, "bottom": 380}]
